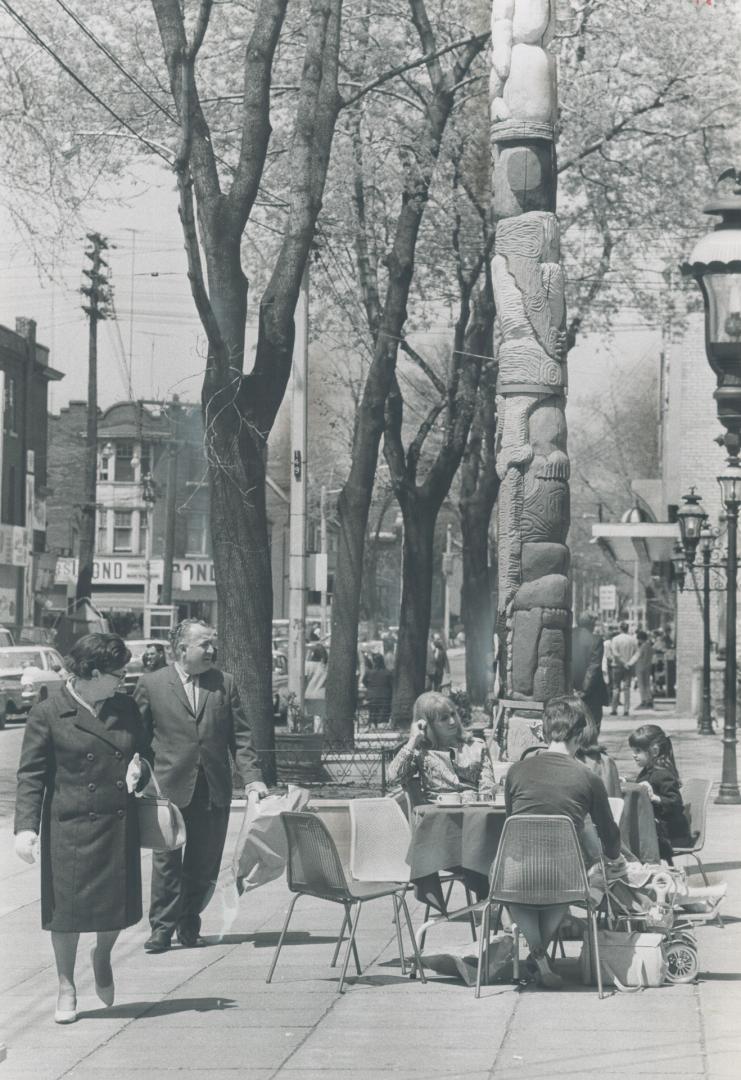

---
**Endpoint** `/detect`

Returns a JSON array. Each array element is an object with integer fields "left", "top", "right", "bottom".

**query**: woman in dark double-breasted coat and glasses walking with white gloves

[{"left": 15, "top": 634, "right": 146, "bottom": 1024}]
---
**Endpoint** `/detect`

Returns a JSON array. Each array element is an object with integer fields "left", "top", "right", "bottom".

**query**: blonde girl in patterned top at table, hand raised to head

[{"left": 389, "top": 690, "right": 497, "bottom": 802}]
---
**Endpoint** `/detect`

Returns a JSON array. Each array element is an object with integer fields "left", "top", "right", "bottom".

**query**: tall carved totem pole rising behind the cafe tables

[{"left": 490, "top": 0, "right": 571, "bottom": 757}]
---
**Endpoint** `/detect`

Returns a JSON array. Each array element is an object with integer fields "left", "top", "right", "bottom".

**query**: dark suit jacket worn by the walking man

[{"left": 134, "top": 666, "right": 262, "bottom": 807}]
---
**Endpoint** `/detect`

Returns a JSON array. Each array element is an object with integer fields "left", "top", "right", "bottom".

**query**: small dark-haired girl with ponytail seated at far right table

[{"left": 628, "top": 724, "right": 691, "bottom": 864}]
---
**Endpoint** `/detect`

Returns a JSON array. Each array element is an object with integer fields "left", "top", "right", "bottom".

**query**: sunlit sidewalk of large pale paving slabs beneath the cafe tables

[{"left": 0, "top": 714, "right": 741, "bottom": 1080}]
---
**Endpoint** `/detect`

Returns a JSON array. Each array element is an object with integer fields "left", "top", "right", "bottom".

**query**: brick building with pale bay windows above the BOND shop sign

[{"left": 49, "top": 401, "right": 287, "bottom": 635}]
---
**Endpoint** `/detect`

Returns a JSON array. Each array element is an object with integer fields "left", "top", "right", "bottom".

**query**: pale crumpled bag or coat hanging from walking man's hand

[{"left": 231, "top": 784, "right": 310, "bottom": 896}]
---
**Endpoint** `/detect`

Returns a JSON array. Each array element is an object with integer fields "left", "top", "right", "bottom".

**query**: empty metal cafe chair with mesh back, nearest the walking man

[{"left": 266, "top": 812, "right": 427, "bottom": 994}]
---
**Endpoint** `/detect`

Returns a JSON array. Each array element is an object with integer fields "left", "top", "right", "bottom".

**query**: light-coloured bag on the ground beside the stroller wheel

[{"left": 580, "top": 930, "right": 666, "bottom": 991}]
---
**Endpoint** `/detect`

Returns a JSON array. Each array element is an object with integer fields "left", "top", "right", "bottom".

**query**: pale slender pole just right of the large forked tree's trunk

[{"left": 288, "top": 261, "right": 309, "bottom": 716}]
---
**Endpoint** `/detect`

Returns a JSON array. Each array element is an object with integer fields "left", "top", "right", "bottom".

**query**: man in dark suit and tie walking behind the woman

[{"left": 134, "top": 619, "right": 268, "bottom": 953}]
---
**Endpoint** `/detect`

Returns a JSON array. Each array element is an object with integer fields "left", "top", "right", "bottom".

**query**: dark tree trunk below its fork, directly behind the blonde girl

[{"left": 391, "top": 495, "right": 436, "bottom": 728}]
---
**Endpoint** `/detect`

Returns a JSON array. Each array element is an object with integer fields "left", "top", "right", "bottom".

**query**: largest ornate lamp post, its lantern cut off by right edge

[{"left": 681, "top": 168, "right": 741, "bottom": 802}]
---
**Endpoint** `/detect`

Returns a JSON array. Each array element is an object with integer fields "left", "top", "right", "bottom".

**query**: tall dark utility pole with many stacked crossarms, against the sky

[{"left": 75, "top": 232, "right": 110, "bottom": 608}]
